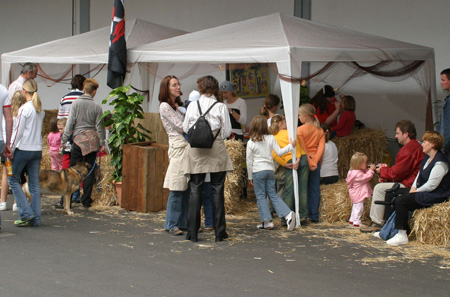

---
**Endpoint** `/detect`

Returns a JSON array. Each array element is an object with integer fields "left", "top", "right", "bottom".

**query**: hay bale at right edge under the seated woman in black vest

[{"left": 411, "top": 201, "right": 450, "bottom": 246}]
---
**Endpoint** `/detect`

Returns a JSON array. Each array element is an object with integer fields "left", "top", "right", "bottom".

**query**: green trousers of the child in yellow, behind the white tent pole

[{"left": 283, "top": 155, "right": 309, "bottom": 219}]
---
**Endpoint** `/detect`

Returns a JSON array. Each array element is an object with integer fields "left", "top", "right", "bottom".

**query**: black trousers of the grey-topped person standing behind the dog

[{"left": 70, "top": 143, "right": 97, "bottom": 207}]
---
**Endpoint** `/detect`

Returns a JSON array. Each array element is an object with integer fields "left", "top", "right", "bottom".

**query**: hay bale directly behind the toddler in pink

[{"left": 319, "top": 180, "right": 372, "bottom": 223}]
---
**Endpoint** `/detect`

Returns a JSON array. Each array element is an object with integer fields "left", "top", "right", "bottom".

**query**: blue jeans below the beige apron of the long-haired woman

[{"left": 164, "top": 188, "right": 190, "bottom": 230}]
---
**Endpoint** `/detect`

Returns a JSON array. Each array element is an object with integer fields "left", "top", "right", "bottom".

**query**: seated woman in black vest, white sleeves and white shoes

[{"left": 376, "top": 131, "right": 450, "bottom": 246}]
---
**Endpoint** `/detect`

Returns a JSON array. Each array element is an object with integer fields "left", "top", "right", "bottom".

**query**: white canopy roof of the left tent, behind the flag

[{"left": 1, "top": 19, "right": 186, "bottom": 107}]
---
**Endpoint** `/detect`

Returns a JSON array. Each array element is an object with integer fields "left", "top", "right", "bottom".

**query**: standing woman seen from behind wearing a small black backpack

[{"left": 183, "top": 75, "right": 233, "bottom": 242}]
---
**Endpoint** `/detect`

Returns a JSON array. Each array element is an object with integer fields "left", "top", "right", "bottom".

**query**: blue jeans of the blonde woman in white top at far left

[{"left": 8, "top": 149, "right": 42, "bottom": 225}]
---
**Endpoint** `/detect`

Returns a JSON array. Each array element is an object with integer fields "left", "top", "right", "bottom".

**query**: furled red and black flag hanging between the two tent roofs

[{"left": 107, "top": 0, "right": 127, "bottom": 89}]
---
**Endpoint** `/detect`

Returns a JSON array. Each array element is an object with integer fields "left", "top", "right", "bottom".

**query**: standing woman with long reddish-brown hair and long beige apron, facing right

[{"left": 158, "top": 75, "right": 189, "bottom": 235}]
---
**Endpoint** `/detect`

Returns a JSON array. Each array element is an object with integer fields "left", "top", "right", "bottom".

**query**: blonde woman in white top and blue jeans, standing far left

[{"left": 8, "top": 79, "right": 45, "bottom": 227}]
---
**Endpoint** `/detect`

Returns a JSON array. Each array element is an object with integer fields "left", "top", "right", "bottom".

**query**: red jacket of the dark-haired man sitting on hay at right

[{"left": 380, "top": 139, "right": 425, "bottom": 188}]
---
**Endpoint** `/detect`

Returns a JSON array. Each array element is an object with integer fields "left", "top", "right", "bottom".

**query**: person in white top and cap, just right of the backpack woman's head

[{"left": 220, "top": 81, "right": 247, "bottom": 141}]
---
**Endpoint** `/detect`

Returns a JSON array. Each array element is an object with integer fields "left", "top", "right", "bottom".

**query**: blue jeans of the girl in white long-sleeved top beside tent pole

[{"left": 253, "top": 170, "right": 291, "bottom": 222}]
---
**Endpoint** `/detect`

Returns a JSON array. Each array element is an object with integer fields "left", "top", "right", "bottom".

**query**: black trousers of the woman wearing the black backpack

[{"left": 187, "top": 172, "right": 226, "bottom": 238}]
